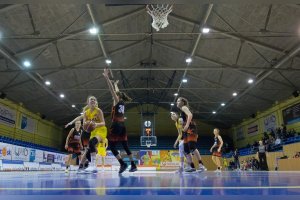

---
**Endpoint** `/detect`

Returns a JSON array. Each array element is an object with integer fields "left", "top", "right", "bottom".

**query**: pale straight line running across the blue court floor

[{"left": 0, "top": 185, "right": 300, "bottom": 191}]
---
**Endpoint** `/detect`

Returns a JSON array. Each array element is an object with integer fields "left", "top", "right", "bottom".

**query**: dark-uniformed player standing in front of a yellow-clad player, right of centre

[{"left": 176, "top": 97, "right": 207, "bottom": 172}]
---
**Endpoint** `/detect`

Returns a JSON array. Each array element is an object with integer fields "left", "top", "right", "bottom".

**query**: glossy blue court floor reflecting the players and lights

[{"left": 0, "top": 171, "right": 300, "bottom": 200}]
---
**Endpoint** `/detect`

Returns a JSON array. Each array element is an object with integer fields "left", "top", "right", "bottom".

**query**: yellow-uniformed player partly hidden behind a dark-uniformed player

[{"left": 171, "top": 112, "right": 195, "bottom": 173}]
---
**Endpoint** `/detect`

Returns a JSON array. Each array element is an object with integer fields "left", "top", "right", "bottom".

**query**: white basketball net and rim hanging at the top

[{"left": 146, "top": 4, "right": 173, "bottom": 31}]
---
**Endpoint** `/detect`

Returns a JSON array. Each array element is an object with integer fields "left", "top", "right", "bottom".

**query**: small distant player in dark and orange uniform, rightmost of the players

[{"left": 210, "top": 128, "right": 223, "bottom": 173}]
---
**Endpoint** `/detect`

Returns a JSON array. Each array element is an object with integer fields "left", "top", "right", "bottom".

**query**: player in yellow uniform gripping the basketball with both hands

[{"left": 79, "top": 96, "right": 107, "bottom": 173}]
